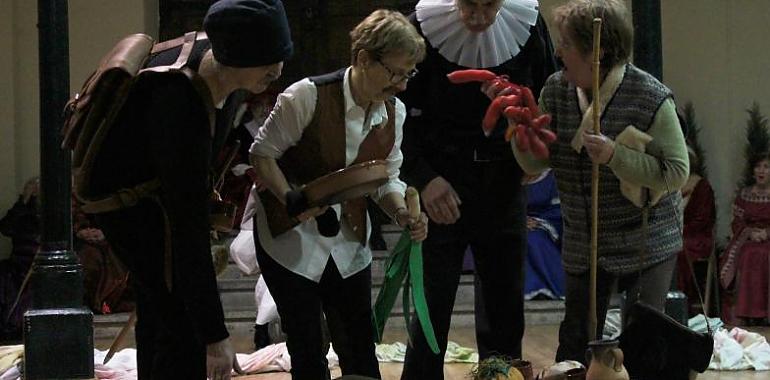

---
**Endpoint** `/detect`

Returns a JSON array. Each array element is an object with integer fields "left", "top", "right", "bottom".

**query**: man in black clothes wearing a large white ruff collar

[{"left": 402, "top": 0, "right": 556, "bottom": 379}]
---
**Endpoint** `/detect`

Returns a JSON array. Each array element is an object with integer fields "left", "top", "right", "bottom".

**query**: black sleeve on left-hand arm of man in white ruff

[{"left": 398, "top": 13, "right": 438, "bottom": 191}]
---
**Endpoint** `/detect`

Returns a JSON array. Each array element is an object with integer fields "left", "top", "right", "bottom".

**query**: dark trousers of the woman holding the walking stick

[{"left": 556, "top": 255, "right": 676, "bottom": 364}]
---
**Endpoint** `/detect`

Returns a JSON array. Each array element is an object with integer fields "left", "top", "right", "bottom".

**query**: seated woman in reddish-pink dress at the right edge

[{"left": 720, "top": 153, "right": 770, "bottom": 324}]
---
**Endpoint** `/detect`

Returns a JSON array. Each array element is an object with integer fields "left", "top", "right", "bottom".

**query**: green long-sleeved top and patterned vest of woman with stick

[{"left": 512, "top": 64, "right": 689, "bottom": 274}]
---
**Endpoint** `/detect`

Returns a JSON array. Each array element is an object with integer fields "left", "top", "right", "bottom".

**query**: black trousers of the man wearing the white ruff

[{"left": 401, "top": 161, "right": 526, "bottom": 380}]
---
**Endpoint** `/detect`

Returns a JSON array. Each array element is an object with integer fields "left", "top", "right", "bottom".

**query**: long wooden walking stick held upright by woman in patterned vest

[{"left": 588, "top": 17, "right": 602, "bottom": 341}]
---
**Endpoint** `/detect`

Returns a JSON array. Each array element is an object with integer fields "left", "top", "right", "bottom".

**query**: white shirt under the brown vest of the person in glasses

[{"left": 250, "top": 68, "right": 406, "bottom": 282}]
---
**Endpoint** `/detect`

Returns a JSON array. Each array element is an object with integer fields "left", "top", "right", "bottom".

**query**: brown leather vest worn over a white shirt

[{"left": 259, "top": 69, "right": 396, "bottom": 245}]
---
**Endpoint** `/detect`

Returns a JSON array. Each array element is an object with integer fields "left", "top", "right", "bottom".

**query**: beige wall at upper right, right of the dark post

[{"left": 662, "top": 0, "right": 770, "bottom": 241}]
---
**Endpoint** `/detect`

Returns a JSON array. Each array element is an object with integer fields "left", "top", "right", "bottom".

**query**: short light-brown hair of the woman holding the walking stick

[{"left": 553, "top": 0, "right": 634, "bottom": 69}]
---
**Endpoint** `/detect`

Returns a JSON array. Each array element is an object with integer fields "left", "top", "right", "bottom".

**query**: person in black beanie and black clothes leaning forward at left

[{"left": 89, "top": 0, "right": 292, "bottom": 380}]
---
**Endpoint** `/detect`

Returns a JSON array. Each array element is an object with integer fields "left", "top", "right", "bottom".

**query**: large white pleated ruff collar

[{"left": 415, "top": 0, "right": 538, "bottom": 68}]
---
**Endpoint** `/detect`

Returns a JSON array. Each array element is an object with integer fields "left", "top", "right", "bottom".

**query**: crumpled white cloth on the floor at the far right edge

[{"left": 709, "top": 327, "right": 770, "bottom": 371}]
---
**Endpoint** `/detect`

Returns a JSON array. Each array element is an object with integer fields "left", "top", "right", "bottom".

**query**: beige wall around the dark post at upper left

[{"left": 0, "top": 0, "right": 158, "bottom": 256}]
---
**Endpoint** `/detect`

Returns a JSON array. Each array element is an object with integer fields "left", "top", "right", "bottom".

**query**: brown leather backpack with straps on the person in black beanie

[{"left": 62, "top": 32, "right": 214, "bottom": 214}]
